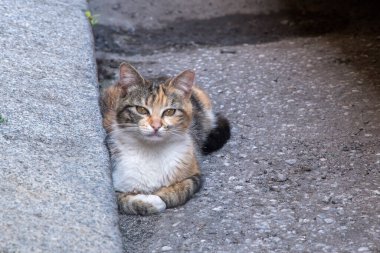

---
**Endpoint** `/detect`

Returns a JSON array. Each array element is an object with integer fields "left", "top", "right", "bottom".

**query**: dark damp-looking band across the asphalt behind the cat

[{"left": 94, "top": 12, "right": 348, "bottom": 55}]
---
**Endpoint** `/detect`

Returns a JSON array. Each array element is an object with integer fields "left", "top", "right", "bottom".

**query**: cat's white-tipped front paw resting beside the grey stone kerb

[{"left": 117, "top": 192, "right": 166, "bottom": 215}]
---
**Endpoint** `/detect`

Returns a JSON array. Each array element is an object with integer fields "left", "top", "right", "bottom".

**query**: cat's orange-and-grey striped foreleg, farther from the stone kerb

[{"left": 154, "top": 174, "right": 202, "bottom": 208}]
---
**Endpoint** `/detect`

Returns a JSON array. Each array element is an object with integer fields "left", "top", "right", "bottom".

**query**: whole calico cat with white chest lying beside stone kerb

[{"left": 100, "top": 62, "right": 230, "bottom": 215}]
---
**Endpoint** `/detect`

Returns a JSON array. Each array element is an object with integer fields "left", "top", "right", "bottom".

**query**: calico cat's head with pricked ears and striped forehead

[{"left": 116, "top": 63, "right": 195, "bottom": 142}]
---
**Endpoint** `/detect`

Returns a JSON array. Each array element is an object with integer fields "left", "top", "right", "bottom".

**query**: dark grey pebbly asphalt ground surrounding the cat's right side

[{"left": 90, "top": 0, "right": 380, "bottom": 253}]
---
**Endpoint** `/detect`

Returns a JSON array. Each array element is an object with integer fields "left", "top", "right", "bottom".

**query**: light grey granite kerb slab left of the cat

[{"left": 0, "top": 0, "right": 122, "bottom": 252}]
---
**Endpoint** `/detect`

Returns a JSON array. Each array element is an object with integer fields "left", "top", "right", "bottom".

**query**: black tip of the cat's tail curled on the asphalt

[{"left": 202, "top": 113, "right": 231, "bottom": 155}]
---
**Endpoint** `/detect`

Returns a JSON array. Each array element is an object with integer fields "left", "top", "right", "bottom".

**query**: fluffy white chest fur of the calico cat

[{"left": 112, "top": 132, "right": 192, "bottom": 193}]
